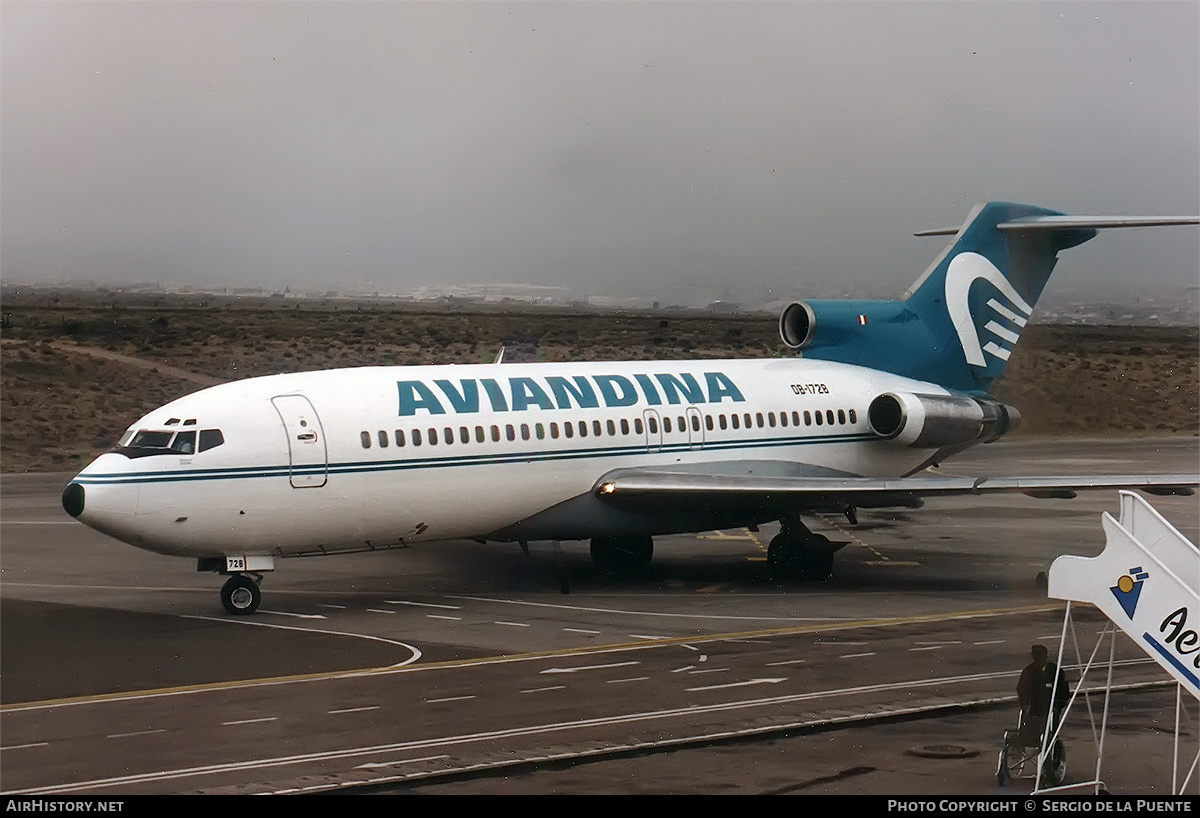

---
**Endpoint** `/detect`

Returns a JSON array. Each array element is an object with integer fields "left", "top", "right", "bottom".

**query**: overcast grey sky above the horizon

[{"left": 0, "top": 0, "right": 1200, "bottom": 301}]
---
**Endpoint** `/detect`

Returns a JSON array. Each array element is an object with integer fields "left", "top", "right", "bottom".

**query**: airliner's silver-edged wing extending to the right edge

[{"left": 593, "top": 469, "right": 1200, "bottom": 511}]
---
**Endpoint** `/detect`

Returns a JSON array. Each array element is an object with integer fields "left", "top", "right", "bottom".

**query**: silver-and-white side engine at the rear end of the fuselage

[{"left": 866, "top": 392, "right": 1021, "bottom": 449}]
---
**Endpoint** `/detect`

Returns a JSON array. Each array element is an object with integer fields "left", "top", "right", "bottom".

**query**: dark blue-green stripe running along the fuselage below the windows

[{"left": 74, "top": 426, "right": 877, "bottom": 486}]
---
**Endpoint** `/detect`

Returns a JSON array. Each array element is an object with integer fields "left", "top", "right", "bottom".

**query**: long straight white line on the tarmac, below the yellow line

[{"left": 7, "top": 660, "right": 1137, "bottom": 795}]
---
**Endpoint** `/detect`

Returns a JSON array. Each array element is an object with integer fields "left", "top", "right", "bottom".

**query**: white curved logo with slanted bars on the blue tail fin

[{"left": 946, "top": 253, "right": 1033, "bottom": 367}]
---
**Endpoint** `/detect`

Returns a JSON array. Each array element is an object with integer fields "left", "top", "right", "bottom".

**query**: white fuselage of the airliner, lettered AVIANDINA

[{"left": 74, "top": 359, "right": 947, "bottom": 557}]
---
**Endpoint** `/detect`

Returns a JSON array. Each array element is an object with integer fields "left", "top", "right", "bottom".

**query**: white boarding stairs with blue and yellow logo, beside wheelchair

[{"left": 1034, "top": 492, "right": 1200, "bottom": 794}]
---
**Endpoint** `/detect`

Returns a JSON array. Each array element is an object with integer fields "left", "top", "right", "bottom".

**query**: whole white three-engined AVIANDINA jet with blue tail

[{"left": 62, "top": 203, "right": 1198, "bottom": 614}]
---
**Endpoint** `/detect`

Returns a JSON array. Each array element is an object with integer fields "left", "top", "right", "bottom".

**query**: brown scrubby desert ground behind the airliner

[{"left": 0, "top": 289, "right": 1200, "bottom": 473}]
